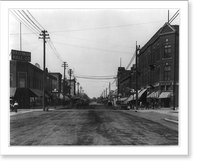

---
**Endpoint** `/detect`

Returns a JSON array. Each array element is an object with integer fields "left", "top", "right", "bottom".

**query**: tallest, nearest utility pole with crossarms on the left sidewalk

[{"left": 39, "top": 30, "right": 50, "bottom": 111}]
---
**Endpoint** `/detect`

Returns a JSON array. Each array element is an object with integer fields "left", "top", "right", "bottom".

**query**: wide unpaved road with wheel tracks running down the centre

[{"left": 10, "top": 105, "right": 178, "bottom": 146}]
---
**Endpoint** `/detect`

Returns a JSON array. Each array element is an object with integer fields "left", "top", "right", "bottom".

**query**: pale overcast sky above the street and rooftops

[{"left": 9, "top": 8, "right": 181, "bottom": 98}]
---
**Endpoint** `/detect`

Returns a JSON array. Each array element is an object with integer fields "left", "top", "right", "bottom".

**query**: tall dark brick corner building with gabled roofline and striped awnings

[{"left": 138, "top": 23, "right": 179, "bottom": 107}]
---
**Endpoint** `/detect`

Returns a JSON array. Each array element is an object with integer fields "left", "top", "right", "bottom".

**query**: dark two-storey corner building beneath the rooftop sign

[{"left": 10, "top": 60, "right": 57, "bottom": 108}]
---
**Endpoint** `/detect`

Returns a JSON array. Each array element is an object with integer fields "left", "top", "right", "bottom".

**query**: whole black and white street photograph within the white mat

[{"left": 1, "top": 2, "right": 188, "bottom": 154}]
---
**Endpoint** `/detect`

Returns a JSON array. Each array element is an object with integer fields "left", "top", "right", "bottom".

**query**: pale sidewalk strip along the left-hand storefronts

[{"left": 10, "top": 105, "right": 63, "bottom": 116}]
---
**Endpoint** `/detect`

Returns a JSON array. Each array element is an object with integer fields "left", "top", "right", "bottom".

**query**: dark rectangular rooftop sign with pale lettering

[{"left": 11, "top": 50, "right": 31, "bottom": 62}]
